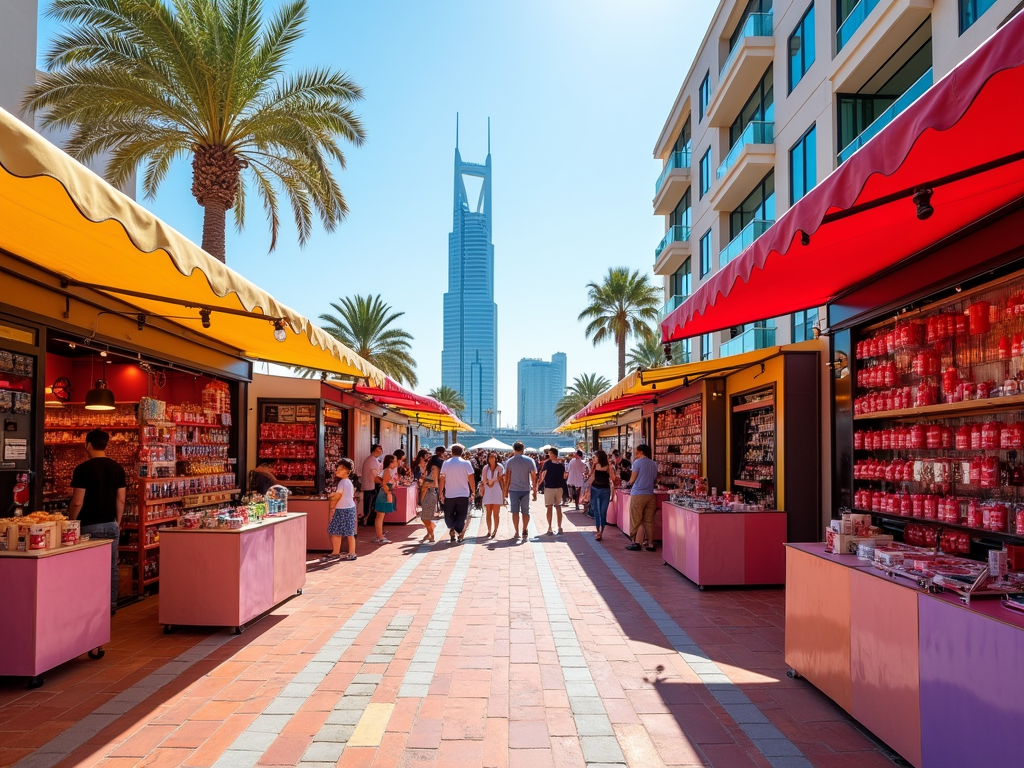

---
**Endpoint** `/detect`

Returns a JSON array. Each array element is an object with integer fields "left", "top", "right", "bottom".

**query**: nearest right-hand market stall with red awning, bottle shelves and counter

[{"left": 663, "top": 14, "right": 1024, "bottom": 768}]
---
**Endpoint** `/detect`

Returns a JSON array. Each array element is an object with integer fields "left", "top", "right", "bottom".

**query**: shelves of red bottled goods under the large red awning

[{"left": 853, "top": 279, "right": 1024, "bottom": 553}]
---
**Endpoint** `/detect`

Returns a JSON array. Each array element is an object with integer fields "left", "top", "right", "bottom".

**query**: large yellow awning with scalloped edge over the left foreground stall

[{"left": 0, "top": 110, "right": 385, "bottom": 383}]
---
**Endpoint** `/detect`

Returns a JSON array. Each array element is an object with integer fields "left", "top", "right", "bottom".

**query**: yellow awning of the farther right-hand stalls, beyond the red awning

[{"left": 555, "top": 347, "right": 782, "bottom": 432}]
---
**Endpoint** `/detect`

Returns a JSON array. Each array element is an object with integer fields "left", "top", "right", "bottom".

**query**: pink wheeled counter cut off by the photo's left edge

[{"left": 0, "top": 539, "right": 111, "bottom": 687}]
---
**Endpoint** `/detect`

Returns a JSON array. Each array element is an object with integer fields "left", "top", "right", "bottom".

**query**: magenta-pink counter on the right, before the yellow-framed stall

[{"left": 662, "top": 502, "right": 785, "bottom": 588}]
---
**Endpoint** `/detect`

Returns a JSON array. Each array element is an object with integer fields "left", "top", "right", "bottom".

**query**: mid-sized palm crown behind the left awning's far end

[{"left": 319, "top": 295, "right": 418, "bottom": 387}]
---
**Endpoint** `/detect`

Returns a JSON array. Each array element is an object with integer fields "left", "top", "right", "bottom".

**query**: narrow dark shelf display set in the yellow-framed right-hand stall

[{"left": 732, "top": 389, "right": 775, "bottom": 509}]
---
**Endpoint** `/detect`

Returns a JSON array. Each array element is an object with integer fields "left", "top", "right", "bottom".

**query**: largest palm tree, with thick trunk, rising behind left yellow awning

[{"left": 23, "top": 0, "right": 366, "bottom": 261}]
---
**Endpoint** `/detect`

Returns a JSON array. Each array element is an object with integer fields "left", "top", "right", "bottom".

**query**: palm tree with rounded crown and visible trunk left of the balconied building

[{"left": 580, "top": 266, "right": 660, "bottom": 381}]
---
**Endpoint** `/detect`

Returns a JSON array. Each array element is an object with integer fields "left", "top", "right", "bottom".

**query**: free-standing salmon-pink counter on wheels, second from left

[{"left": 159, "top": 512, "right": 306, "bottom": 632}]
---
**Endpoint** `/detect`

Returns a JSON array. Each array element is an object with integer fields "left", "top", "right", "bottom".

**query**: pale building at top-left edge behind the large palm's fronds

[{"left": 0, "top": 0, "right": 135, "bottom": 200}]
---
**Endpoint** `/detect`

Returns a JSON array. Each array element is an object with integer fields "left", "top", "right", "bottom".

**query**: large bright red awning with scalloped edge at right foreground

[{"left": 662, "top": 13, "right": 1024, "bottom": 341}]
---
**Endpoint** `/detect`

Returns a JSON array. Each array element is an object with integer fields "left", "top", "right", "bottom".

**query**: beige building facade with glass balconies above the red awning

[{"left": 653, "top": 0, "right": 1024, "bottom": 362}]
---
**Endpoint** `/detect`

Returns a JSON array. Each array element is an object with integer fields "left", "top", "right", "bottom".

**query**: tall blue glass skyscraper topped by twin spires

[{"left": 441, "top": 118, "right": 498, "bottom": 429}]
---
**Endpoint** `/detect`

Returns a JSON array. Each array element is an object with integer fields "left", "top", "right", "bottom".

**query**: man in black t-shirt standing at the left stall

[{"left": 68, "top": 429, "right": 127, "bottom": 615}]
